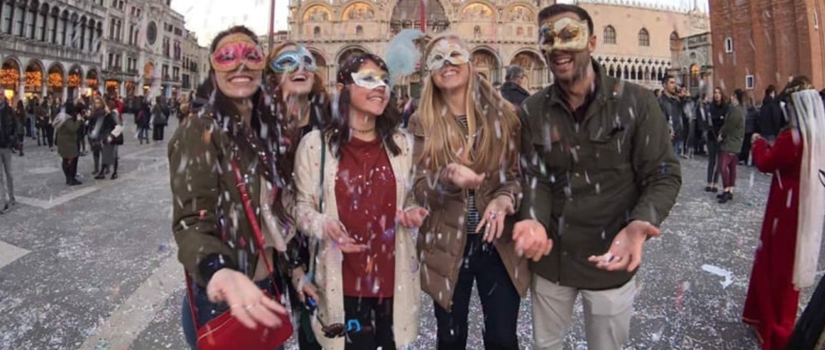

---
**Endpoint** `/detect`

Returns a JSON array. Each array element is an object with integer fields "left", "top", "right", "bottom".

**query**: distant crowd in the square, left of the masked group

[{"left": 0, "top": 92, "right": 183, "bottom": 214}]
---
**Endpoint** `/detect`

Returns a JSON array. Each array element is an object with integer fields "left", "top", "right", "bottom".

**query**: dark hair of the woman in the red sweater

[{"left": 323, "top": 53, "right": 401, "bottom": 158}]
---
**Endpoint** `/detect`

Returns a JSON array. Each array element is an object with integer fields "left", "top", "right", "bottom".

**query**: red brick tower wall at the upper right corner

[{"left": 710, "top": 0, "right": 825, "bottom": 101}]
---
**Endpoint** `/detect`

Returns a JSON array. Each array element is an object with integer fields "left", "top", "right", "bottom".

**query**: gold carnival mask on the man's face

[{"left": 539, "top": 17, "right": 590, "bottom": 53}]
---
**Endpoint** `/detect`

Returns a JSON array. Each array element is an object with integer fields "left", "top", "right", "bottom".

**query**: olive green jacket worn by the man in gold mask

[{"left": 520, "top": 61, "right": 682, "bottom": 290}]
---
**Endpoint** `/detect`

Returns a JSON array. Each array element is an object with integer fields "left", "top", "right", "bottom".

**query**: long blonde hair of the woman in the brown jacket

[{"left": 417, "top": 33, "right": 521, "bottom": 173}]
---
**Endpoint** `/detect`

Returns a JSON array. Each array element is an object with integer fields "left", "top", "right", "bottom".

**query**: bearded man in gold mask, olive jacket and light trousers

[{"left": 513, "top": 4, "right": 682, "bottom": 350}]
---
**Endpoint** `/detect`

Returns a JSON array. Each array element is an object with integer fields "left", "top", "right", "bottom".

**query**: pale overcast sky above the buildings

[{"left": 172, "top": 0, "right": 708, "bottom": 45}]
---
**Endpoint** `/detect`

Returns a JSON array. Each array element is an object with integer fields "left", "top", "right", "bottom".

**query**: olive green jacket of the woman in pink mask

[{"left": 168, "top": 115, "right": 266, "bottom": 286}]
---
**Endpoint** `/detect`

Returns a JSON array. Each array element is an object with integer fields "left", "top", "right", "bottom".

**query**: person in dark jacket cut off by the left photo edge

[{"left": 0, "top": 94, "right": 17, "bottom": 214}]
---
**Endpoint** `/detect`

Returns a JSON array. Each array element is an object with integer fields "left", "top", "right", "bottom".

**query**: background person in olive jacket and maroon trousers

[{"left": 718, "top": 89, "right": 745, "bottom": 204}]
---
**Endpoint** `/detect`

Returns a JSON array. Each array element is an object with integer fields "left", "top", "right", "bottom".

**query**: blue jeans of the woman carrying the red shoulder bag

[{"left": 181, "top": 279, "right": 284, "bottom": 350}]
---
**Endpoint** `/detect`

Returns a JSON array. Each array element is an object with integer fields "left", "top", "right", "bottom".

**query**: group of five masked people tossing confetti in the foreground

[{"left": 168, "top": 4, "right": 681, "bottom": 350}]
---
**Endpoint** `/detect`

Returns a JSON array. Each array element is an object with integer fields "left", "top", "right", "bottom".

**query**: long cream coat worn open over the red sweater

[{"left": 294, "top": 130, "right": 421, "bottom": 350}]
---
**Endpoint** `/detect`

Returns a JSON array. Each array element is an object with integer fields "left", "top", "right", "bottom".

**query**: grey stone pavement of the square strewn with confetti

[{"left": 0, "top": 124, "right": 825, "bottom": 350}]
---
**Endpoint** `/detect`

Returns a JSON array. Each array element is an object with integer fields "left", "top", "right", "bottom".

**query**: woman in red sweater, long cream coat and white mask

[{"left": 295, "top": 54, "right": 428, "bottom": 350}]
